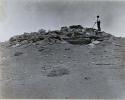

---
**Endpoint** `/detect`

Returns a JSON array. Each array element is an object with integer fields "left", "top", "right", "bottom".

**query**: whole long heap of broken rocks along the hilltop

[{"left": 9, "top": 25, "right": 111, "bottom": 45}]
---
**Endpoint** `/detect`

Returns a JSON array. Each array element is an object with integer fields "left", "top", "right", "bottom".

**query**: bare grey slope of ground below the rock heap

[{"left": 0, "top": 26, "right": 125, "bottom": 99}]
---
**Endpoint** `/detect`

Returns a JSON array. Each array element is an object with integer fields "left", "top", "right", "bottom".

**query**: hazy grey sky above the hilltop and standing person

[{"left": 0, "top": 0, "right": 125, "bottom": 41}]
